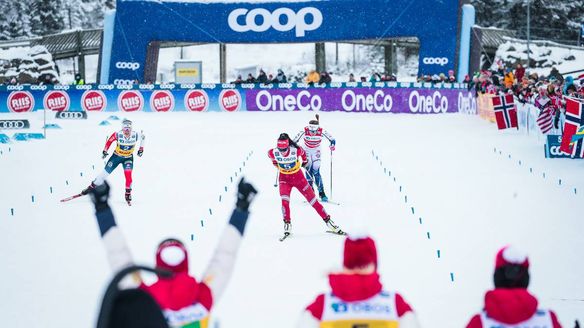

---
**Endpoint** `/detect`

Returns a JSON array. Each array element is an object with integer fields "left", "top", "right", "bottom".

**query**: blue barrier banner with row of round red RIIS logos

[{"left": 0, "top": 85, "right": 245, "bottom": 113}]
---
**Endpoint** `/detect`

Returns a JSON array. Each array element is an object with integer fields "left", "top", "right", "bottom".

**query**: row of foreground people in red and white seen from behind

[{"left": 90, "top": 180, "right": 578, "bottom": 328}]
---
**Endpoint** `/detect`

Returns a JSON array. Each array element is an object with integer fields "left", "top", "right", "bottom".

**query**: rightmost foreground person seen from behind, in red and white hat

[{"left": 466, "top": 246, "right": 562, "bottom": 328}]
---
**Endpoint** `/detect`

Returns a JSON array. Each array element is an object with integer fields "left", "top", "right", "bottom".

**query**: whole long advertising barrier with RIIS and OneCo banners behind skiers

[{"left": 0, "top": 82, "right": 477, "bottom": 114}]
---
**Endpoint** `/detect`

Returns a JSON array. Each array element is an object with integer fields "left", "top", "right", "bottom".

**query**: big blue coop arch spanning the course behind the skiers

[{"left": 107, "top": 0, "right": 460, "bottom": 83}]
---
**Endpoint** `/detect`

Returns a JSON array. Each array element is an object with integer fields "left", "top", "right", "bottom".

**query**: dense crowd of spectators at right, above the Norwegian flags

[{"left": 468, "top": 63, "right": 584, "bottom": 133}]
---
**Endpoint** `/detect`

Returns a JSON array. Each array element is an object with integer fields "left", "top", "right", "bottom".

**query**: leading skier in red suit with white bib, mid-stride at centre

[{"left": 268, "top": 133, "right": 343, "bottom": 236}]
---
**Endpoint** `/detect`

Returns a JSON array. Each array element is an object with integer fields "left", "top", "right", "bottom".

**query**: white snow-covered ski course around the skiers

[{"left": 0, "top": 112, "right": 584, "bottom": 328}]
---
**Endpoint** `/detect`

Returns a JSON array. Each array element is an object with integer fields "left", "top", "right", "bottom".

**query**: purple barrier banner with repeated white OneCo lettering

[{"left": 246, "top": 88, "right": 476, "bottom": 114}]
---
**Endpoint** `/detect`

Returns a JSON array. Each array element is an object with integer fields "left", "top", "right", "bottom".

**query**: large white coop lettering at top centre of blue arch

[{"left": 227, "top": 7, "right": 323, "bottom": 38}]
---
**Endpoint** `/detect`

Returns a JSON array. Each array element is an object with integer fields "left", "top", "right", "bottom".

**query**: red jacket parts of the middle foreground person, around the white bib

[{"left": 306, "top": 273, "right": 413, "bottom": 320}]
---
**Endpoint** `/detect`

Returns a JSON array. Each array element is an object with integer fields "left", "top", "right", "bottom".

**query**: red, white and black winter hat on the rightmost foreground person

[{"left": 493, "top": 246, "right": 529, "bottom": 288}]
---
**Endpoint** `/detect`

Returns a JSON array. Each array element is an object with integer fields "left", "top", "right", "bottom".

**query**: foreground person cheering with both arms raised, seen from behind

[{"left": 90, "top": 179, "right": 257, "bottom": 328}]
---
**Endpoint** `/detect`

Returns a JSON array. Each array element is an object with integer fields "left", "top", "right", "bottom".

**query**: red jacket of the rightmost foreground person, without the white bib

[{"left": 466, "top": 288, "right": 562, "bottom": 328}]
